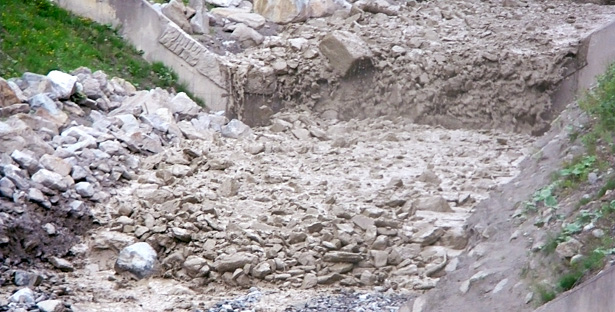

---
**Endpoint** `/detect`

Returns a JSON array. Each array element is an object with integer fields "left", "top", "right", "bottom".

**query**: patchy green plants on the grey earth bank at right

[{"left": 523, "top": 64, "right": 615, "bottom": 303}]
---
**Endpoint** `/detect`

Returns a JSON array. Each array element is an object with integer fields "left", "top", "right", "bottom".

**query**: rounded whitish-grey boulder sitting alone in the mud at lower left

[{"left": 114, "top": 242, "right": 157, "bottom": 279}]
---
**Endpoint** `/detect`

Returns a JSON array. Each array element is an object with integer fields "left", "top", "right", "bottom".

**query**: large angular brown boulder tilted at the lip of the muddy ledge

[{"left": 319, "top": 31, "right": 373, "bottom": 77}]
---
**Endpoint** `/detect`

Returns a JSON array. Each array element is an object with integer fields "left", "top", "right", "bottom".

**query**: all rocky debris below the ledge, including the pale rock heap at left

[{"left": 0, "top": 68, "right": 532, "bottom": 309}]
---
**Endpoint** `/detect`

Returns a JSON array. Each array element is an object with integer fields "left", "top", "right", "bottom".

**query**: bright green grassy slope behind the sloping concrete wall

[{"left": 0, "top": 0, "right": 203, "bottom": 104}]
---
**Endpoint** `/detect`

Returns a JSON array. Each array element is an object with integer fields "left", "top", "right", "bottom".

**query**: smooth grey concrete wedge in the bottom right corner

[{"left": 535, "top": 266, "right": 615, "bottom": 312}]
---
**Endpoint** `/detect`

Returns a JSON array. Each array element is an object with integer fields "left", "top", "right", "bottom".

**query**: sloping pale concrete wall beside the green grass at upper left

[{"left": 57, "top": 0, "right": 230, "bottom": 110}]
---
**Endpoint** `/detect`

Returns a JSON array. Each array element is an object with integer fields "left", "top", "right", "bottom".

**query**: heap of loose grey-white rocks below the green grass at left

[{"left": 0, "top": 68, "right": 249, "bottom": 276}]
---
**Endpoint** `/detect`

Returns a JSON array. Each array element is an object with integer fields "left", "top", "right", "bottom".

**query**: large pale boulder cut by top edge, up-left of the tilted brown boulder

[{"left": 254, "top": 0, "right": 309, "bottom": 24}]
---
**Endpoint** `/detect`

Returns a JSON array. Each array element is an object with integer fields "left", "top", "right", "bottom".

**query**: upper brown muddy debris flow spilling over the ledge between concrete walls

[{"left": 152, "top": 0, "right": 615, "bottom": 134}]
